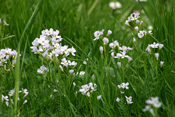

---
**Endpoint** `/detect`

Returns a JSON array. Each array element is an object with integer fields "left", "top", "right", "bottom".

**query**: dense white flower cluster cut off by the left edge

[{"left": 0, "top": 48, "right": 18, "bottom": 71}]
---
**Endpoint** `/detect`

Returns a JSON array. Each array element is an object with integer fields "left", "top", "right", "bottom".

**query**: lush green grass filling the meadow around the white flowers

[{"left": 0, "top": 0, "right": 175, "bottom": 117}]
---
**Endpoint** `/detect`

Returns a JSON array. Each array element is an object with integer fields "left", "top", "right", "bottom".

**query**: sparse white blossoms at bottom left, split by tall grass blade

[{"left": 2, "top": 88, "right": 29, "bottom": 106}]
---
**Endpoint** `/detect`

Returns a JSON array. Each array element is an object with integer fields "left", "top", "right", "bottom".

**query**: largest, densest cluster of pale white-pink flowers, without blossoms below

[{"left": 31, "top": 28, "right": 76, "bottom": 59}]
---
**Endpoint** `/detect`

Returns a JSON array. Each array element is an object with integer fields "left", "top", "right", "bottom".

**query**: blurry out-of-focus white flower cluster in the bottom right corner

[{"left": 143, "top": 97, "right": 162, "bottom": 115}]
